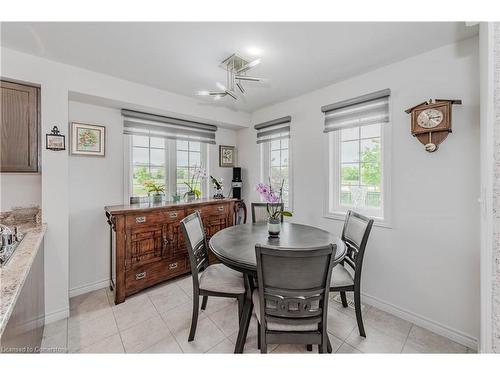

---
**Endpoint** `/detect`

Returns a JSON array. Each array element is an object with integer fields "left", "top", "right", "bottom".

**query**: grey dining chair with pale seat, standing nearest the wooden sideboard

[{"left": 181, "top": 211, "right": 245, "bottom": 341}]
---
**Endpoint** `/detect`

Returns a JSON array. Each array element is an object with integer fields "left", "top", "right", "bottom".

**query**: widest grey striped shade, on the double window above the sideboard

[{"left": 122, "top": 109, "right": 217, "bottom": 144}]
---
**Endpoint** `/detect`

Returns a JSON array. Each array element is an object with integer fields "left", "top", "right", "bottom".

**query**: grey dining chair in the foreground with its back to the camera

[{"left": 252, "top": 245, "right": 335, "bottom": 353}]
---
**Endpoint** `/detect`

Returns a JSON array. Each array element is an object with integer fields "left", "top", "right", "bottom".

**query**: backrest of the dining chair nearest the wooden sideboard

[{"left": 181, "top": 211, "right": 208, "bottom": 284}]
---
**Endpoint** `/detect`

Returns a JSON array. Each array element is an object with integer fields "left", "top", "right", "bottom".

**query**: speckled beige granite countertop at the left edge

[{"left": 0, "top": 224, "right": 47, "bottom": 337}]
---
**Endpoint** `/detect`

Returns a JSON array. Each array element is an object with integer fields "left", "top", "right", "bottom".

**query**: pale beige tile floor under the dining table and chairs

[{"left": 42, "top": 277, "right": 472, "bottom": 353}]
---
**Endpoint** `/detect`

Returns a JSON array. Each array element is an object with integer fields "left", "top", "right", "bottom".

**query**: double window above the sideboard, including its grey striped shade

[{"left": 121, "top": 109, "right": 217, "bottom": 201}]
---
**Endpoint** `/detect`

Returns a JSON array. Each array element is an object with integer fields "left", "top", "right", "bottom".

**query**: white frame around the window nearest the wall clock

[{"left": 324, "top": 114, "right": 392, "bottom": 228}]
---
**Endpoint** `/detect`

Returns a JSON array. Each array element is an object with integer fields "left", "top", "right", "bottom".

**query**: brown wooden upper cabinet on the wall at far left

[{"left": 0, "top": 81, "right": 40, "bottom": 172}]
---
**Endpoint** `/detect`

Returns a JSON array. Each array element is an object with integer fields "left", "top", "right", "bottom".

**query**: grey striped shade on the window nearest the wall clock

[{"left": 321, "top": 89, "right": 391, "bottom": 133}]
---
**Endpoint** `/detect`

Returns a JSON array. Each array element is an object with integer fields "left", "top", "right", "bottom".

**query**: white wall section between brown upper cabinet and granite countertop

[{"left": 0, "top": 173, "right": 42, "bottom": 212}]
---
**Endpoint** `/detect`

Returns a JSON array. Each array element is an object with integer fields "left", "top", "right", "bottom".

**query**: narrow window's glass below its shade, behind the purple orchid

[{"left": 262, "top": 138, "right": 291, "bottom": 208}]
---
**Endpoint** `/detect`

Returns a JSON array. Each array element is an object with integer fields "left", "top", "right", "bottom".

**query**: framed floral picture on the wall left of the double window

[{"left": 71, "top": 122, "right": 106, "bottom": 156}]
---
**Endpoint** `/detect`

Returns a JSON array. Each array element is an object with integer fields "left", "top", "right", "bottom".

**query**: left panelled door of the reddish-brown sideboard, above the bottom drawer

[{"left": 125, "top": 225, "right": 166, "bottom": 269}]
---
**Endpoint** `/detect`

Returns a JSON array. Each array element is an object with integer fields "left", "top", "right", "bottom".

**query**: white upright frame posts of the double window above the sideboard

[{"left": 123, "top": 135, "right": 210, "bottom": 203}]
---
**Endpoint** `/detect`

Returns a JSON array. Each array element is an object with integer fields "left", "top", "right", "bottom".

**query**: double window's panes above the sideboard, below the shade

[{"left": 129, "top": 135, "right": 208, "bottom": 199}]
